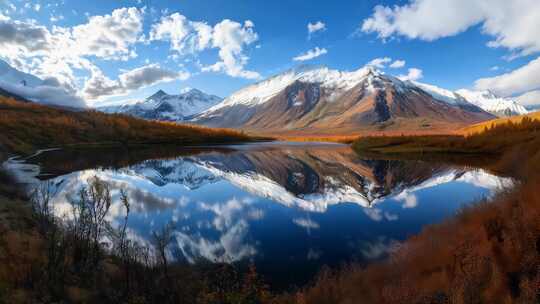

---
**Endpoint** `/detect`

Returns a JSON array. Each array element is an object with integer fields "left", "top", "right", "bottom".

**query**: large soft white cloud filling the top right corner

[{"left": 361, "top": 0, "right": 540, "bottom": 55}]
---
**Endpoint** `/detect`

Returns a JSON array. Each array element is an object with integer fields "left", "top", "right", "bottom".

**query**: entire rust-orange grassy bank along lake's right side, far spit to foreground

[{"left": 291, "top": 118, "right": 540, "bottom": 303}]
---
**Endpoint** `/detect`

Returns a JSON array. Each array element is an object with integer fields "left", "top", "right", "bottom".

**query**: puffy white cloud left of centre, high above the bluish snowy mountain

[{"left": 150, "top": 13, "right": 260, "bottom": 79}]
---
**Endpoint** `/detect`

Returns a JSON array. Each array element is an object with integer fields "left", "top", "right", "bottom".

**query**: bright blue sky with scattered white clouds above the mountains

[{"left": 0, "top": 0, "right": 540, "bottom": 104}]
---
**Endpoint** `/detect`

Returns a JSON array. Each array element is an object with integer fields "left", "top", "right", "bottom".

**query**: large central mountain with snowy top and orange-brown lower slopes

[{"left": 194, "top": 66, "right": 494, "bottom": 134}]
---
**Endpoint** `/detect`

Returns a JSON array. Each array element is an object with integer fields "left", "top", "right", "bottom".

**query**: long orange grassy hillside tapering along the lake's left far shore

[{"left": 0, "top": 97, "right": 260, "bottom": 153}]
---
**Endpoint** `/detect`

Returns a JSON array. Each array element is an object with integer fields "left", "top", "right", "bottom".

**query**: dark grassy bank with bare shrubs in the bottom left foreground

[{"left": 0, "top": 174, "right": 273, "bottom": 304}]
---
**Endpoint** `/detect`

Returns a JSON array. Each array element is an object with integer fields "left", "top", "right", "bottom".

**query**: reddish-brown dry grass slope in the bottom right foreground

[{"left": 295, "top": 179, "right": 540, "bottom": 304}]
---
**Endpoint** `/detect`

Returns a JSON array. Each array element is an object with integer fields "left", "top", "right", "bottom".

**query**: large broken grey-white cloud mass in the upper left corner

[{"left": 0, "top": 6, "right": 144, "bottom": 104}]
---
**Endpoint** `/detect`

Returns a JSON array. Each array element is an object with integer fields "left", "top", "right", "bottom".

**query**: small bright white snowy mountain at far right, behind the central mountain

[{"left": 456, "top": 89, "right": 529, "bottom": 116}]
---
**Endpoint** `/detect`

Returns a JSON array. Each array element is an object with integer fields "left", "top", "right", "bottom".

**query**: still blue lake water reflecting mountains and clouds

[{"left": 7, "top": 143, "right": 511, "bottom": 287}]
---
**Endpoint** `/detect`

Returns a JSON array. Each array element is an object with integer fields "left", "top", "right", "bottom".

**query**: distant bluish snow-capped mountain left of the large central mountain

[{"left": 98, "top": 88, "right": 222, "bottom": 121}]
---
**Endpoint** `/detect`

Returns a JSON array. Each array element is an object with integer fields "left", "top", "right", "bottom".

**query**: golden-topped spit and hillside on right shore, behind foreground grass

[{"left": 353, "top": 116, "right": 540, "bottom": 179}]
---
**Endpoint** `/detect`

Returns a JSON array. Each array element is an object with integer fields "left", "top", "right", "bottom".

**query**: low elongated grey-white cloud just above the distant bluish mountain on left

[{"left": 84, "top": 64, "right": 190, "bottom": 100}]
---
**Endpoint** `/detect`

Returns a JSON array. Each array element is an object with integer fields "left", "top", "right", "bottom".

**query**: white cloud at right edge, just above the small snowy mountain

[{"left": 475, "top": 57, "right": 540, "bottom": 96}]
